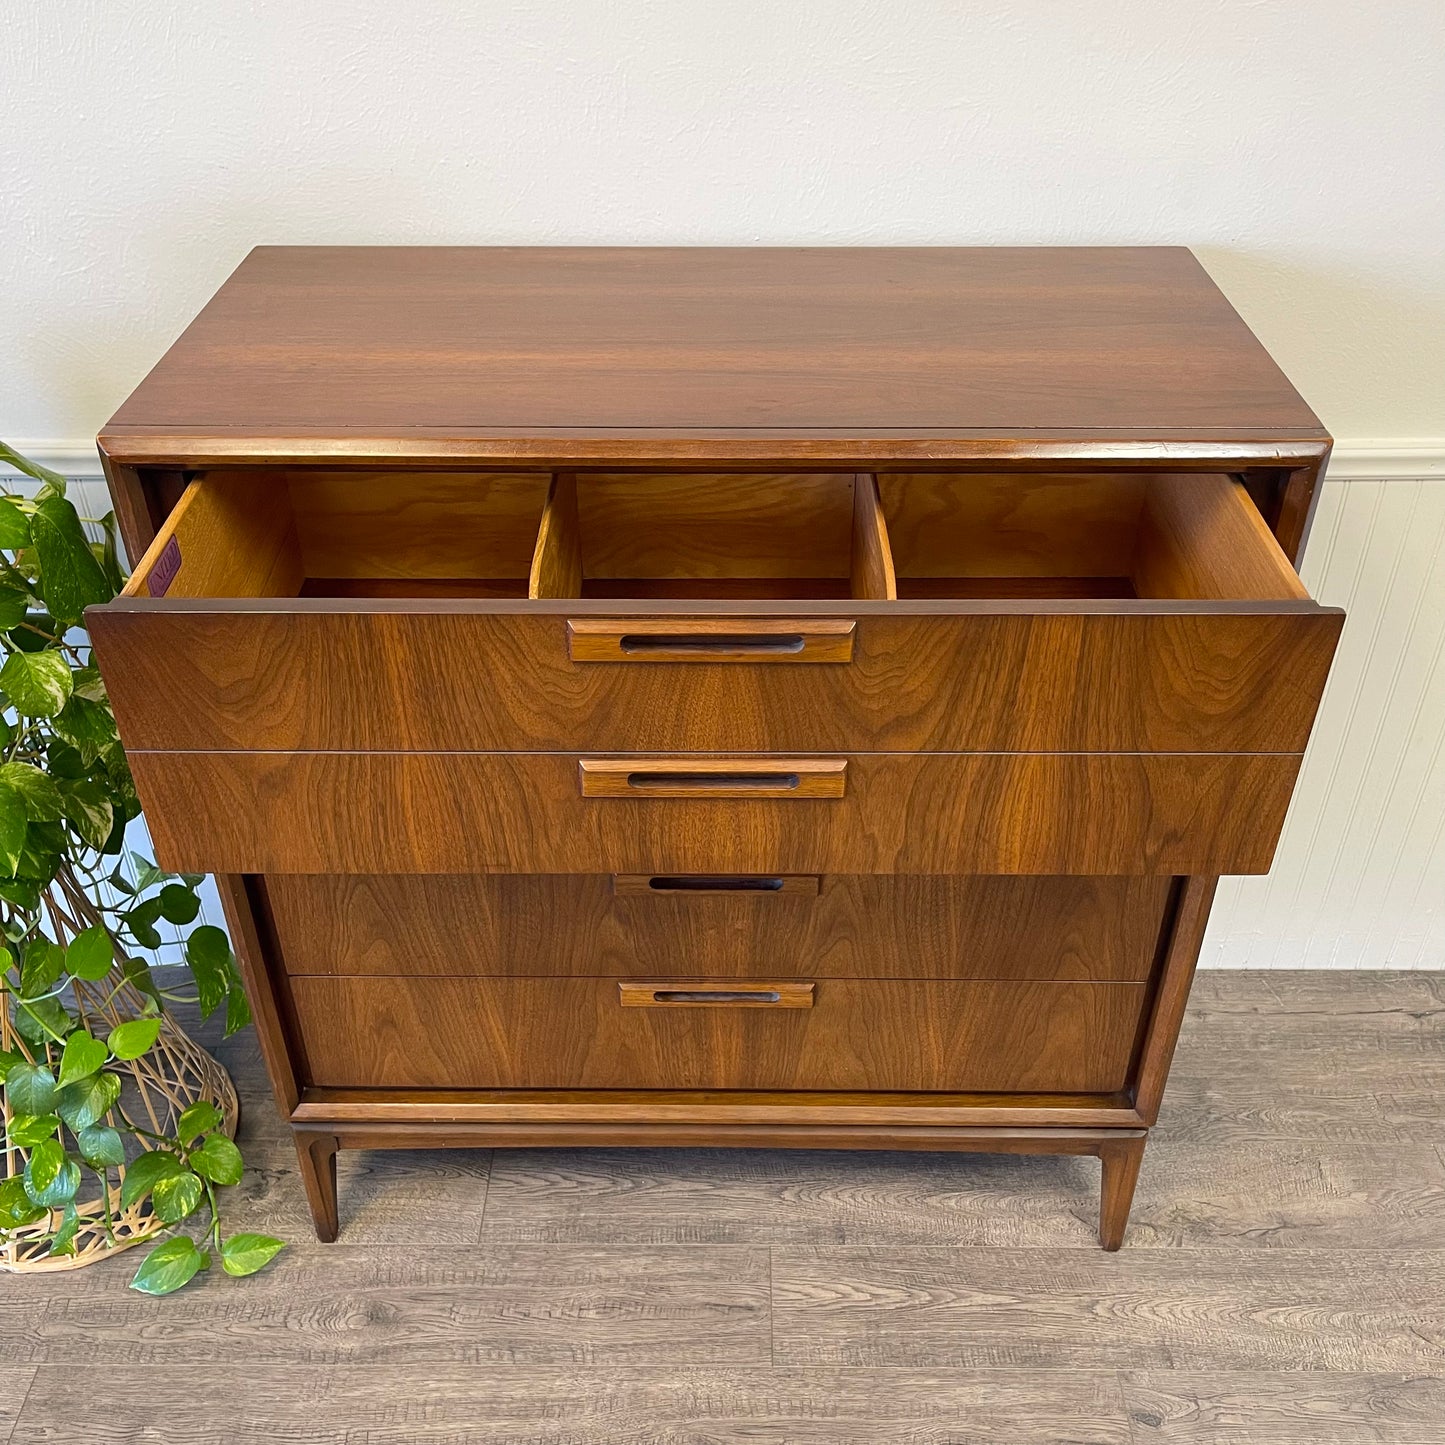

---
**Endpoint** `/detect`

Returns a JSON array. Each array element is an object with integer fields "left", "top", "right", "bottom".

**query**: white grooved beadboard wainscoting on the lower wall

[{"left": 5, "top": 439, "right": 1445, "bottom": 968}]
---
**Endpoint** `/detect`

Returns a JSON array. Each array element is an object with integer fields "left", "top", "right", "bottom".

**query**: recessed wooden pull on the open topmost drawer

[{"left": 566, "top": 617, "right": 857, "bottom": 662}]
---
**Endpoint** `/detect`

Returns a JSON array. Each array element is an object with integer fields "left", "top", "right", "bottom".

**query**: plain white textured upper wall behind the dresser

[{"left": 0, "top": 0, "right": 1445, "bottom": 441}]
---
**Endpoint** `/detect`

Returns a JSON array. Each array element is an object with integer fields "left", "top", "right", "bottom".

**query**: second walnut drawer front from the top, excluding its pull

[{"left": 130, "top": 753, "right": 1299, "bottom": 874}]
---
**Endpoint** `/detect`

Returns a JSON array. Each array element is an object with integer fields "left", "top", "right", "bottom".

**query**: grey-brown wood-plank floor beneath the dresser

[{"left": 0, "top": 974, "right": 1445, "bottom": 1445}]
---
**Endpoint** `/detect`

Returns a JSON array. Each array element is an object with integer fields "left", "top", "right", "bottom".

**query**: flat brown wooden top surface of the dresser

[{"left": 101, "top": 246, "right": 1325, "bottom": 464}]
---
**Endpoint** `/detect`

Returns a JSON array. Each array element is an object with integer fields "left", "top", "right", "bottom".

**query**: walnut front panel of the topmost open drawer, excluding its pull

[{"left": 88, "top": 598, "right": 1341, "bottom": 753}]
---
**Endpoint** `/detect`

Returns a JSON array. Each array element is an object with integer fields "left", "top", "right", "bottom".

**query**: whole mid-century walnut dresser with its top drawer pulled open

[{"left": 88, "top": 247, "right": 1342, "bottom": 1248}]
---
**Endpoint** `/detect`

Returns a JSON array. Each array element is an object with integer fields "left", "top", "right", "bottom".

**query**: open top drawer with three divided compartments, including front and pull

[{"left": 88, "top": 471, "right": 1341, "bottom": 754}]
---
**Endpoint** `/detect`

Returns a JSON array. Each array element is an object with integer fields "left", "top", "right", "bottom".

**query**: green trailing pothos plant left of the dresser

[{"left": 0, "top": 444, "right": 282, "bottom": 1295}]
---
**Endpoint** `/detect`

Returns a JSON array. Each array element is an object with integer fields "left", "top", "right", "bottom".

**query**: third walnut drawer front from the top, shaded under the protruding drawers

[{"left": 264, "top": 874, "right": 1172, "bottom": 981}]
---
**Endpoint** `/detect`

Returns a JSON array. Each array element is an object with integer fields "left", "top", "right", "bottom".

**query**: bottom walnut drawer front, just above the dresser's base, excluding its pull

[{"left": 290, "top": 977, "right": 1147, "bottom": 1092}]
